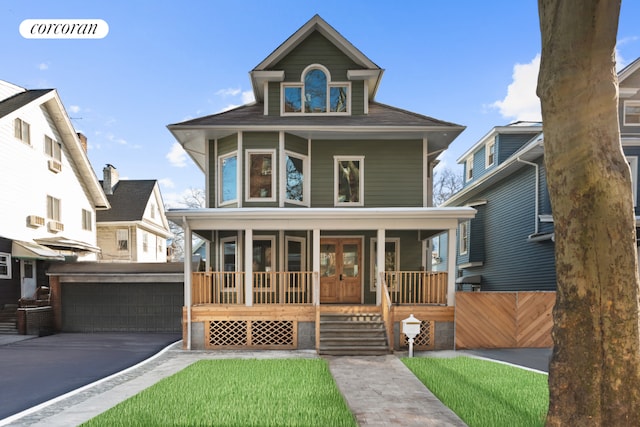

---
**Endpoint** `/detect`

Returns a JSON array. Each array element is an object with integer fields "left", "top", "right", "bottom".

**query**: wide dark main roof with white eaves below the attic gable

[{"left": 168, "top": 101, "right": 465, "bottom": 171}]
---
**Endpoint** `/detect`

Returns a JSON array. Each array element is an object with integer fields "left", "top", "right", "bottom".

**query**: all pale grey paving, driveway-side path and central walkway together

[{"left": 0, "top": 342, "right": 465, "bottom": 427}]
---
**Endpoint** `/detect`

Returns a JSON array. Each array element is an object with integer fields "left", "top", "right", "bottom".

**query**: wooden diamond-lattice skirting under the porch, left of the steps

[{"left": 205, "top": 320, "right": 298, "bottom": 350}]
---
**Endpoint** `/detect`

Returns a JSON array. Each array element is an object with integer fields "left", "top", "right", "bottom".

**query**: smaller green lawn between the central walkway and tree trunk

[{"left": 402, "top": 357, "right": 549, "bottom": 427}]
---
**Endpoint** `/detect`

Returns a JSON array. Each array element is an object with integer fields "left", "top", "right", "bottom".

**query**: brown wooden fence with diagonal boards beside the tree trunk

[{"left": 455, "top": 292, "right": 556, "bottom": 349}]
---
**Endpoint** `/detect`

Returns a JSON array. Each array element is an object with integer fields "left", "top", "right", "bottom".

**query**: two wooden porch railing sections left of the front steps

[{"left": 191, "top": 271, "right": 313, "bottom": 305}]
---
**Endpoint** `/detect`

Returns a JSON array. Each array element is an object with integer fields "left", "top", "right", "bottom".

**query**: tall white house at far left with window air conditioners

[{"left": 0, "top": 80, "right": 109, "bottom": 305}]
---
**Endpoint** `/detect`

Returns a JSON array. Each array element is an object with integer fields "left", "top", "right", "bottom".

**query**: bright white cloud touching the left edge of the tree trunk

[{"left": 490, "top": 54, "right": 542, "bottom": 121}]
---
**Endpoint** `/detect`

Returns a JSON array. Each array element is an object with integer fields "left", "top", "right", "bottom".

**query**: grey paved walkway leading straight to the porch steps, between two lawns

[{"left": 327, "top": 355, "right": 466, "bottom": 427}]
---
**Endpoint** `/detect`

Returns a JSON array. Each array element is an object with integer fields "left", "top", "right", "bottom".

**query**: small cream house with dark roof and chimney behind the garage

[{"left": 97, "top": 165, "right": 173, "bottom": 262}]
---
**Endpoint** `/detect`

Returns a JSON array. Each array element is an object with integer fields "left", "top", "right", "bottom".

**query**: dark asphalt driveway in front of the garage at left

[{"left": 0, "top": 332, "right": 182, "bottom": 420}]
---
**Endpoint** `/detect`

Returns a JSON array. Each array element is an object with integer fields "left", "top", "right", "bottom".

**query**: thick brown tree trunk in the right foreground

[{"left": 538, "top": 0, "right": 640, "bottom": 426}]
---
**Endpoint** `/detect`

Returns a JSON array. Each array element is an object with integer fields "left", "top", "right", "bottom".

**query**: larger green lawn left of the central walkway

[{"left": 83, "top": 359, "right": 357, "bottom": 427}]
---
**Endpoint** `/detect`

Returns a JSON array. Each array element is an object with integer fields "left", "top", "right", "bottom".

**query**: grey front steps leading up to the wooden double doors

[{"left": 319, "top": 313, "right": 390, "bottom": 356}]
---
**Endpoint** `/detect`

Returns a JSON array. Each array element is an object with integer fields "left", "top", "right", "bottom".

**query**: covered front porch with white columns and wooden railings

[{"left": 167, "top": 208, "right": 475, "bottom": 350}]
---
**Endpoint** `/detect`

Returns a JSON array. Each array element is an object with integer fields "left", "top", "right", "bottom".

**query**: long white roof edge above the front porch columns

[{"left": 166, "top": 207, "right": 476, "bottom": 230}]
